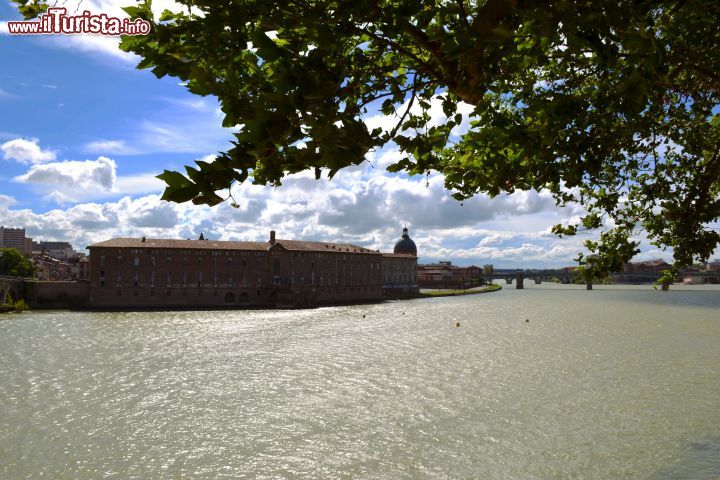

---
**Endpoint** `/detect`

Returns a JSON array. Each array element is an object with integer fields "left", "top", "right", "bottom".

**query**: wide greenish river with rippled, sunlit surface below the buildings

[{"left": 0, "top": 282, "right": 720, "bottom": 480}]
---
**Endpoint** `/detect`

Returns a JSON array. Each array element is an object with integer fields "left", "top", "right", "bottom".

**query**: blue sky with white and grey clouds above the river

[{"left": 0, "top": 0, "right": 696, "bottom": 268}]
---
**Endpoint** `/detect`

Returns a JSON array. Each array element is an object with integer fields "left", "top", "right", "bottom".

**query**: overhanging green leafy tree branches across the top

[{"left": 15, "top": 0, "right": 720, "bottom": 282}]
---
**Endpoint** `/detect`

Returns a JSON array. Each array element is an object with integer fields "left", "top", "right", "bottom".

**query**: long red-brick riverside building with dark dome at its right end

[{"left": 88, "top": 229, "right": 418, "bottom": 309}]
